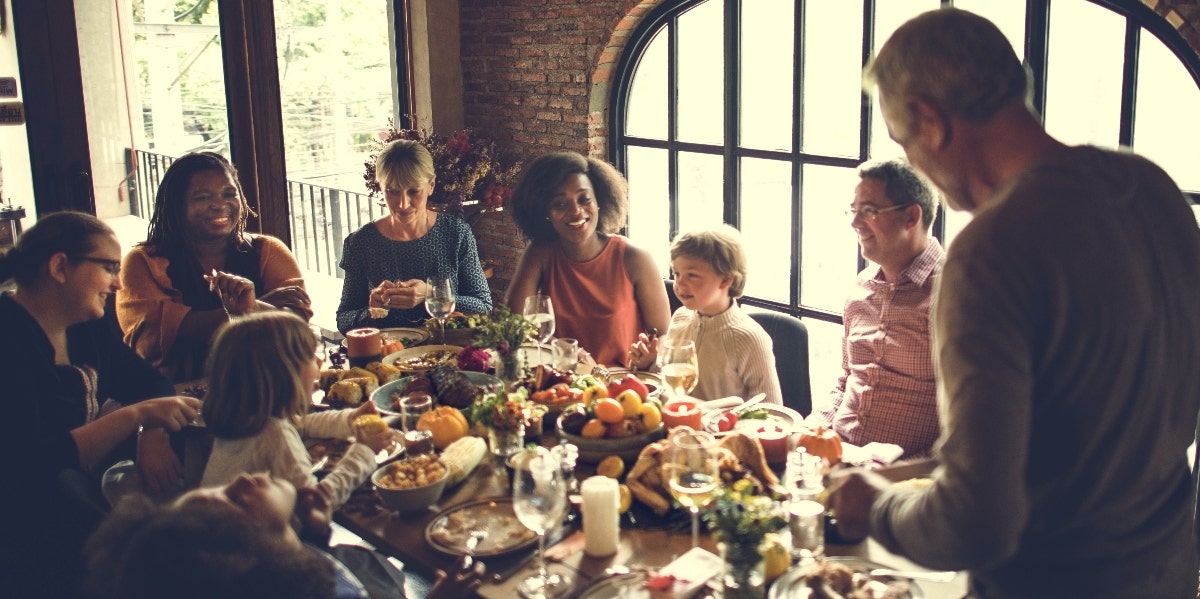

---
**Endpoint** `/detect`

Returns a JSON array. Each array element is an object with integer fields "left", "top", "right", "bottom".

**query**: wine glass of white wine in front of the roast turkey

[{"left": 662, "top": 426, "right": 721, "bottom": 547}]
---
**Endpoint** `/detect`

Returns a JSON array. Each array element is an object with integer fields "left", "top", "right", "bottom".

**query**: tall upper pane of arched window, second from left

[{"left": 678, "top": 0, "right": 725, "bottom": 144}]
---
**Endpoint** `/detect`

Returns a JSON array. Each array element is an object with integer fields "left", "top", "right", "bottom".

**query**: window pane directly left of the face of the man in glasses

[{"left": 800, "top": 164, "right": 858, "bottom": 313}]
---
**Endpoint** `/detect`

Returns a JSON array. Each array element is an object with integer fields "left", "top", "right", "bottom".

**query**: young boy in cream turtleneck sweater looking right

[{"left": 629, "top": 224, "right": 782, "bottom": 403}]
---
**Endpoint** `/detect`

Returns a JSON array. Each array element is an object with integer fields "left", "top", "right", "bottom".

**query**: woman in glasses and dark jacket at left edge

[{"left": 0, "top": 212, "right": 199, "bottom": 597}]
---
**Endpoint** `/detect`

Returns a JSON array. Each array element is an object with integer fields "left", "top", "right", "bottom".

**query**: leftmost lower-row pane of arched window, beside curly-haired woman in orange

[{"left": 626, "top": 146, "right": 671, "bottom": 276}]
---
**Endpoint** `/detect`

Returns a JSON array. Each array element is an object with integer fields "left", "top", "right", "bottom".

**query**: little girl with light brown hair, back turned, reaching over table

[{"left": 200, "top": 311, "right": 392, "bottom": 509}]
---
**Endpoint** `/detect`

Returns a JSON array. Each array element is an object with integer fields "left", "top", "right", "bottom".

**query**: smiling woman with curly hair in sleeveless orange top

[{"left": 506, "top": 151, "right": 671, "bottom": 366}]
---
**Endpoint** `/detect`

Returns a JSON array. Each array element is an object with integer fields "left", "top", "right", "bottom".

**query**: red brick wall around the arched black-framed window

[{"left": 460, "top": 0, "right": 1200, "bottom": 299}]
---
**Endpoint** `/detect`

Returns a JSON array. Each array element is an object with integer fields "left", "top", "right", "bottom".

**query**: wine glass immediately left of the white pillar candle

[{"left": 512, "top": 448, "right": 571, "bottom": 599}]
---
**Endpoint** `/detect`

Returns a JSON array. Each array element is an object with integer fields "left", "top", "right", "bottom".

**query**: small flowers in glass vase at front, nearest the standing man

[{"left": 703, "top": 479, "right": 787, "bottom": 598}]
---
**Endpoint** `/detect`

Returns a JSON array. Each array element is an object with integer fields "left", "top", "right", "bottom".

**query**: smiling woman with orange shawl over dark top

[{"left": 116, "top": 152, "right": 312, "bottom": 383}]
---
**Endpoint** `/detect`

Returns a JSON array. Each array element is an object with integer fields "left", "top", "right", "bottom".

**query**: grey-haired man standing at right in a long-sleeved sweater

[{"left": 830, "top": 8, "right": 1200, "bottom": 599}]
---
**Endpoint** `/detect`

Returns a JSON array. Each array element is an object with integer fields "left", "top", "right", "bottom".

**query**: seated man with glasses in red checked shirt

[{"left": 809, "top": 160, "right": 944, "bottom": 457}]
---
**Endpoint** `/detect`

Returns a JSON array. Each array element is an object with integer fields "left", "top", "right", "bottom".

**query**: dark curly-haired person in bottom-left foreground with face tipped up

[{"left": 84, "top": 474, "right": 485, "bottom": 599}]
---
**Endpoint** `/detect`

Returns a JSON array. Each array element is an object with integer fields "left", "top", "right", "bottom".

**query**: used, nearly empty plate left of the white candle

[{"left": 425, "top": 497, "right": 538, "bottom": 557}]
